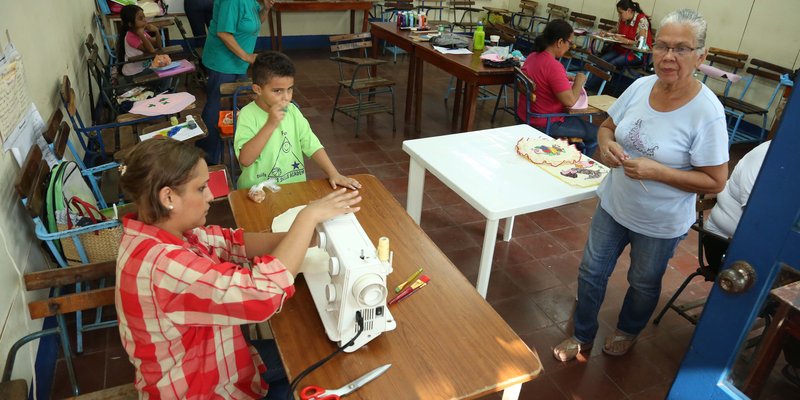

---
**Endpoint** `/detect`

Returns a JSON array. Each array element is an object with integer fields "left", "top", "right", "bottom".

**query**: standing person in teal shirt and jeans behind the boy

[{"left": 197, "top": 0, "right": 274, "bottom": 165}]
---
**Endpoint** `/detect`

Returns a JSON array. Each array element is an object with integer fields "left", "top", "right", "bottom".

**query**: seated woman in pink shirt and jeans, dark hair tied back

[{"left": 517, "top": 19, "right": 597, "bottom": 156}]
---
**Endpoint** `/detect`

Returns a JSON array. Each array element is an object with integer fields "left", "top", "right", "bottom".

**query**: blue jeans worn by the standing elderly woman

[{"left": 574, "top": 205, "right": 686, "bottom": 343}]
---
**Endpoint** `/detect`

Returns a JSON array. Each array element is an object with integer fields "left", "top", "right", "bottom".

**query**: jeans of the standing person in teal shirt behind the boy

[{"left": 197, "top": 69, "right": 247, "bottom": 165}]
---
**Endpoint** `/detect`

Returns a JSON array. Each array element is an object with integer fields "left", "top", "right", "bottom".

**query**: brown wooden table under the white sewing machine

[{"left": 228, "top": 175, "right": 542, "bottom": 400}]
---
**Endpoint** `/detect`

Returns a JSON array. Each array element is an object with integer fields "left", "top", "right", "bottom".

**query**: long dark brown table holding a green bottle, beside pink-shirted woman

[{"left": 371, "top": 22, "right": 514, "bottom": 133}]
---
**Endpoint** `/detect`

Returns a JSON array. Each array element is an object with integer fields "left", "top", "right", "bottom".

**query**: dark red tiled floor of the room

[{"left": 52, "top": 51, "right": 797, "bottom": 400}]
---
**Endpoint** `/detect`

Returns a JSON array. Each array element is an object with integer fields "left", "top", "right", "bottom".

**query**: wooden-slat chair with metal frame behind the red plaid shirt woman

[{"left": 2, "top": 261, "right": 118, "bottom": 399}]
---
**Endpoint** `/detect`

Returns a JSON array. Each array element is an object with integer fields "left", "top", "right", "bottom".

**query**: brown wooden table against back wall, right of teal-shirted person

[{"left": 269, "top": 0, "right": 375, "bottom": 51}]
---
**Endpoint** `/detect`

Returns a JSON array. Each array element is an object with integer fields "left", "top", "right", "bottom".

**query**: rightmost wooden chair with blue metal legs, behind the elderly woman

[{"left": 719, "top": 58, "right": 794, "bottom": 146}]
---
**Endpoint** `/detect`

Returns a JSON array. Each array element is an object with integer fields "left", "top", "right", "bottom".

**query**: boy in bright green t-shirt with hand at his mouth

[{"left": 233, "top": 51, "right": 361, "bottom": 190}]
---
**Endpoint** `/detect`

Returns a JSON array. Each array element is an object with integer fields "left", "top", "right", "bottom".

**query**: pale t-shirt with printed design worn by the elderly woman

[{"left": 597, "top": 75, "right": 728, "bottom": 239}]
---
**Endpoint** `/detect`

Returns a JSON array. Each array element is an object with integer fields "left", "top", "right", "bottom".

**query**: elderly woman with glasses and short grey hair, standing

[{"left": 553, "top": 9, "right": 728, "bottom": 361}]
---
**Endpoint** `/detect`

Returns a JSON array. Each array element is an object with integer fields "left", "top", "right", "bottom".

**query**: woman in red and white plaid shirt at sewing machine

[{"left": 116, "top": 138, "right": 361, "bottom": 399}]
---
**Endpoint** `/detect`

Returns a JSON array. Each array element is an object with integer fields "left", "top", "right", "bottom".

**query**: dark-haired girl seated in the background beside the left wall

[{"left": 117, "top": 5, "right": 170, "bottom": 76}]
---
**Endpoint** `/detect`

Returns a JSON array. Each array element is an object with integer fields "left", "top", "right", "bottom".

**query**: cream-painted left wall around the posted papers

[{"left": 0, "top": 0, "right": 95, "bottom": 396}]
